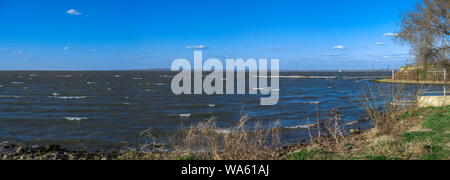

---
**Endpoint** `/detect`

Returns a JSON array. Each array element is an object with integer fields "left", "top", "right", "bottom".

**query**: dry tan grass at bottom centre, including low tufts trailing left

[{"left": 133, "top": 116, "right": 282, "bottom": 160}]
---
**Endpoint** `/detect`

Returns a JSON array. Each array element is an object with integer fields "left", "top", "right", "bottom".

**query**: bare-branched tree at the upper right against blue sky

[{"left": 395, "top": 0, "right": 450, "bottom": 66}]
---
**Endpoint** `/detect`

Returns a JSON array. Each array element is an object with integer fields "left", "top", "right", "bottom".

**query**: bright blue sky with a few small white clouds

[{"left": 0, "top": 0, "right": 419, "bottom": 70}]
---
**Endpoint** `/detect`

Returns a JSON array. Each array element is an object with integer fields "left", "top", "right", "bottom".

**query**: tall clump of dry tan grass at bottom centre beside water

[{"left": 174, "top": 116, "right": 280, "bottom": 160}]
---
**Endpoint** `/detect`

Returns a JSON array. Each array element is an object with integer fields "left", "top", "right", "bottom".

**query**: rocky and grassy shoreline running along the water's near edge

[{"left": 0, "top": 106, "right": 450, "bottom": 160}]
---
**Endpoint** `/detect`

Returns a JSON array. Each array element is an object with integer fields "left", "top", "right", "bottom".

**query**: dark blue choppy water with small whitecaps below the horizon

[{"left": 0, "top": 71, "right": 389, "bottom": 150}]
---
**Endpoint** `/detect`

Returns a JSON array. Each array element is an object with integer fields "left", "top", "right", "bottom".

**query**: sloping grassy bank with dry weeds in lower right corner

[{"left": 286, "top": 106, "right": 450, "bottom": 160}]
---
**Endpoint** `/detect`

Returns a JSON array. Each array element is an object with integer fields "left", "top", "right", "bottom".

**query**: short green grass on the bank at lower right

[{"left": 286, "top": 106, "right": 450, "bottom": 160}]
